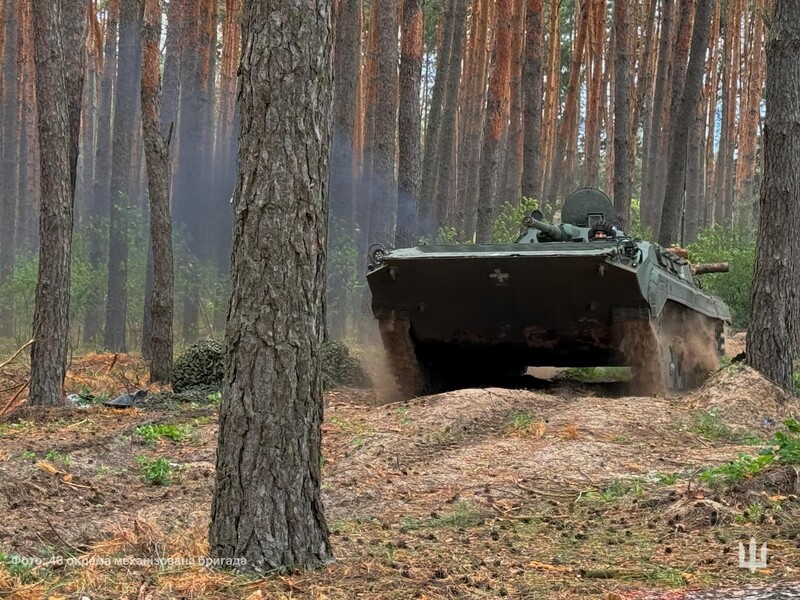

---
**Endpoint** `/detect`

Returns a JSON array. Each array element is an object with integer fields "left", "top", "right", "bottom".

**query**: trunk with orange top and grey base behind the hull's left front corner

[{"left": 396, "top": 0, "right": 424, "bottom": 248}]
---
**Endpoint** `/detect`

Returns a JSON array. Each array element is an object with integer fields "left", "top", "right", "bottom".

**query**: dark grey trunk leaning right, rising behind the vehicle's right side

[{"left": 658, "top": 0, "right": 715, "bottom": 246}]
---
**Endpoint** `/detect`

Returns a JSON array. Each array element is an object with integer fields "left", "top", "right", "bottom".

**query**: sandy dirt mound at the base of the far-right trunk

[{"left": 684, "top": 364, "right": 798, "bottom": 429}]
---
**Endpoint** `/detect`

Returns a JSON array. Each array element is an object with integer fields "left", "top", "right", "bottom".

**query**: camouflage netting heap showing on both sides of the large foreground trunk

[{"left": 172, "top": 340, "right": 372, "bottom": 395}]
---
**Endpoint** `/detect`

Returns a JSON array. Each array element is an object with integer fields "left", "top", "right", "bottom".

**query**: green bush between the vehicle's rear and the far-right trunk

[{"left": 689, "top": 225, "right": 756, "bottom": 327}]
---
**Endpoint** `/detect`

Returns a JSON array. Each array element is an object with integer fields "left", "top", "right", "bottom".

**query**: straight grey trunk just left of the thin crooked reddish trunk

[{"left": 104, "top": 0, "right": 141, "bottom": 352}]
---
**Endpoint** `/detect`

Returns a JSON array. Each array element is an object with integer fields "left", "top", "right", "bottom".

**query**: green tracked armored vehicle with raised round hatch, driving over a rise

[{"left": 367, "top": 188, "right": 730, "bottom": 397}]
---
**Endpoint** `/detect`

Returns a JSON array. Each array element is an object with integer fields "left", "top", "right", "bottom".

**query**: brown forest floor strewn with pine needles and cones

[{"left": 0, "top": 330, "right": 800, "bottom": 600}]
